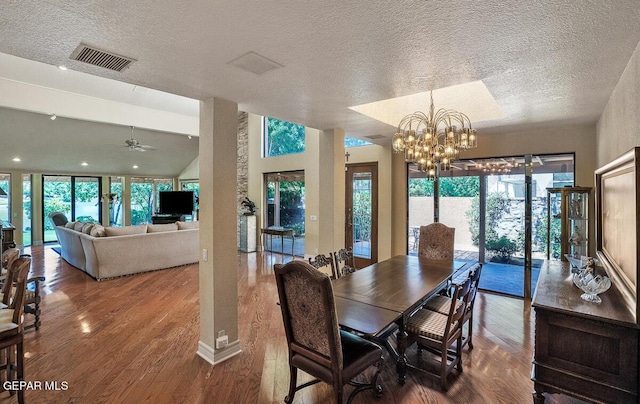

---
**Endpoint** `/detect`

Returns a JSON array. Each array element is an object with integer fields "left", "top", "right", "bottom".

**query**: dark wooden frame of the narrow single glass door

[{"left": 344, "top": 161, "right": 378, "bottom": 268}]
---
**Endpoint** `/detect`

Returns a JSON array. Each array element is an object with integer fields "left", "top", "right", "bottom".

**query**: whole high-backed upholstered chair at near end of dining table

[{"left": 274, "top": 260, "right": 383, "bottom": 404}]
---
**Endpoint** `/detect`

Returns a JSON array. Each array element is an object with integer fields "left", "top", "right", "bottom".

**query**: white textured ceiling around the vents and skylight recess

[{"left": 0, "top": 0, "right": 640, "bottom": 145}]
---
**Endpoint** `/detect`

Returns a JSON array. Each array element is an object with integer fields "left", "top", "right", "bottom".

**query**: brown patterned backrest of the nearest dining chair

[{"left": 274, "top": 260, "right": 343, "bottom": 369}]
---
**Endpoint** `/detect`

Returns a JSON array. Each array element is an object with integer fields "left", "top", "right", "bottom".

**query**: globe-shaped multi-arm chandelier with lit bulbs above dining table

[{"left": 393, "top": 92, "right": 478, "bottom": 179}]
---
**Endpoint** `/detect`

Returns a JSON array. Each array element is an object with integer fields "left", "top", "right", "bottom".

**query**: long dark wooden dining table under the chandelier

[{"left": 333, "top": 255, "right": 470, "bottom": 384}]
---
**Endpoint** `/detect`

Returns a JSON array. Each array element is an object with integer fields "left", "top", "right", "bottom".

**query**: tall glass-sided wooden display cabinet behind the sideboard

[{"left": 547, "top": 187, "right": 592, "bottom": 261}]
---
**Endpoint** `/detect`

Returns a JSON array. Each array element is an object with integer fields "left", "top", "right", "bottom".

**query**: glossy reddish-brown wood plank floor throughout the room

[{"left": 0, "top": 247, "right": 574, "bottom": 404}]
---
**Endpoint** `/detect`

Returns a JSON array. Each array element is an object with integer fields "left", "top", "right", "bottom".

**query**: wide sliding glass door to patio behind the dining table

[{"left": 407, "top": 154, "right": 574, "bottom": 296}]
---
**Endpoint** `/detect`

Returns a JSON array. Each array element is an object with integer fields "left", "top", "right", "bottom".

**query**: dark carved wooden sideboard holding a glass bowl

[{"left": 531, "top": 261, "right": 639, "bottom": 404}]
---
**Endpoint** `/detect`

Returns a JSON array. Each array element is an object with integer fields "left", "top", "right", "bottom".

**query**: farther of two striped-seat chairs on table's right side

[{"left": 422, "top": 262, "right": 482, "bottom": 350}]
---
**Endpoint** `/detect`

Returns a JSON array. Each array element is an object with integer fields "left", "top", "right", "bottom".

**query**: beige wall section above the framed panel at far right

[{"left": 596, "top": 44, "right": 640, "bottom": 167}]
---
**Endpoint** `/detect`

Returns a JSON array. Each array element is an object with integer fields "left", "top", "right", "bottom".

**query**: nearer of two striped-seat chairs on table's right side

[{"left": 406, "top": 279, "right": 471, "bottom": 391}]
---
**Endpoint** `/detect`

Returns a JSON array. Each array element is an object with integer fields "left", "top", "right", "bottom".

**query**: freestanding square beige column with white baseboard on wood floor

[{"left": 198, "top": 98, "right": 241, "bottom": 365}]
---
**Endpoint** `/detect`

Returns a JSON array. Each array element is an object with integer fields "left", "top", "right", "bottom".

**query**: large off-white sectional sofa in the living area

[{"left": 55, "top": 222, "right": 200, "bottom": 280}]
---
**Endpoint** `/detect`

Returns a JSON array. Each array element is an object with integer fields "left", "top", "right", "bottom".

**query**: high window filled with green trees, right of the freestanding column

[{"left": 262, "top": 116, "right": 304, "bottom": 157}]
